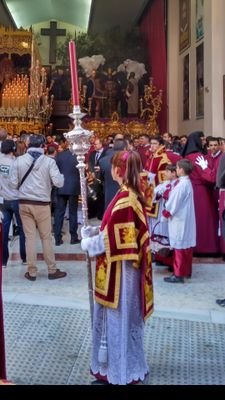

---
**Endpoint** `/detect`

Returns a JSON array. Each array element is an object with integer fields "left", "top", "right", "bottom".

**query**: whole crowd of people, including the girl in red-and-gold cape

[{"left": 0, "top": 129, "right": 225, "bottom": 384}]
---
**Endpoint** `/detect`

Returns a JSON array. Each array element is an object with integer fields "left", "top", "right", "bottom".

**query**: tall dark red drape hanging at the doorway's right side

[{"left": 140, "top": 0, "right": 167, "bottom": 133}]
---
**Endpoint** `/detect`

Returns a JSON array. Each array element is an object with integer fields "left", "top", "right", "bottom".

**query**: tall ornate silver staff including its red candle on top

[{"left": 64, "top": 41, "right": 94, "bottom": 324}]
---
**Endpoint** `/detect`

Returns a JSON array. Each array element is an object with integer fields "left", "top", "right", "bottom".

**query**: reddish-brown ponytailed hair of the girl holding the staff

[{"left": 112, "top": 151, "right": 145, "bottom": 206}]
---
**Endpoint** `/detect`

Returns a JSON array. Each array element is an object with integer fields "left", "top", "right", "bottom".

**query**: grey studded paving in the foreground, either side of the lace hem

[{"left": 5, "top": 303, "right": 225, "bottom": 385}]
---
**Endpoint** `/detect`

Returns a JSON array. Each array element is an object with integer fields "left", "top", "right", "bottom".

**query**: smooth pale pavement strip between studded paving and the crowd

[{"left": 3, "top": 260, "right": 225, "bottom": 324}]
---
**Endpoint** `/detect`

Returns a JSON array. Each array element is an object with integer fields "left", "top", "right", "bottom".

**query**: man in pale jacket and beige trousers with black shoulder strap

[{"left": 10, "top": 134, "right": 67, "bottom": 282}]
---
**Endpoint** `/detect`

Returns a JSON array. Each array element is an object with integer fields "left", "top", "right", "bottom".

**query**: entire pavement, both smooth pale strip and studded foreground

[{"left": 3, "top": 222, "right": 225, "bottom": 385}]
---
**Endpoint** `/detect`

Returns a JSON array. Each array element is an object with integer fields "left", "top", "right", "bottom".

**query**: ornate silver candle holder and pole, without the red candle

[{"left": 64, "top": 106, "right": 94, "bottom": 323}]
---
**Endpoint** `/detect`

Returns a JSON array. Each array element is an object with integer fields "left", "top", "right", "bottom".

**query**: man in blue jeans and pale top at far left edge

[{"left": 0, "top": 139, "right": 26, "bottom": 267}]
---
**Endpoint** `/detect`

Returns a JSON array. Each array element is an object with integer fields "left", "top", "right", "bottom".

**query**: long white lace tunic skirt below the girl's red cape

[{"left": 91, "top": 261, "right": 149, "bottom": 385}]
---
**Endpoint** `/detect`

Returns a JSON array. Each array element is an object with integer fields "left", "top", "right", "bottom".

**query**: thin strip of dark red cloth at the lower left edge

[{"left": 0, "top": 223, "right": 6, "bottom": 379}]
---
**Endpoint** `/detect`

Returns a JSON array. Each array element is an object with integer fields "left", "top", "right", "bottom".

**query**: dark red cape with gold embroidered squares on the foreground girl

[{"left": 95, "top": 186, "right": 153, "bottom": 319}]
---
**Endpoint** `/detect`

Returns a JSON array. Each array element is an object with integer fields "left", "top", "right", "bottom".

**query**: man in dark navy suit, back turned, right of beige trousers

[{"left": 54, "top": 138, "right": 80, "bottom": 246}]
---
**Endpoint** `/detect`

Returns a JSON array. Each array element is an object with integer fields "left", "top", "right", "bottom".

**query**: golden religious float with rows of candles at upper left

[{"left": 0, "top": 27, "right": 53, "bottom": 135}]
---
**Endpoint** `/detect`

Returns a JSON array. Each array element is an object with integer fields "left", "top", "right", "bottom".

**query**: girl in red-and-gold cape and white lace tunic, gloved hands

[{"left": 81, "top": 151, "right": 153, "bottom": 385}]
